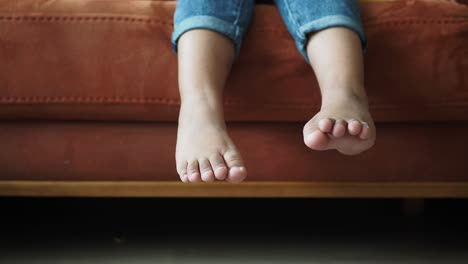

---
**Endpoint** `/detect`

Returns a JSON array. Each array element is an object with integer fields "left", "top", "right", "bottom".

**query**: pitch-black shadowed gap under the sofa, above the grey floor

[{"left": 0, "top": 198, "right": 468, "bottom": 238}]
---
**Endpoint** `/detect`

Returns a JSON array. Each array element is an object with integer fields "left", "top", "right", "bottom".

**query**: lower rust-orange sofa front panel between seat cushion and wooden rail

[{"left": 0, "top": 121, "right": 468, "bottom": 182}]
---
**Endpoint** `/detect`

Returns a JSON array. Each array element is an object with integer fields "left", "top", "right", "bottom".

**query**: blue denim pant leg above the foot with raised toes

[{"left": 275, "top": 0, "right": 367, "bottom": 62}]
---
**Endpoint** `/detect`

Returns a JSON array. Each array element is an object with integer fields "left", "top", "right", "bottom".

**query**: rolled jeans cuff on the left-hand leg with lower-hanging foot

[{"left": 172, "top": 16, "right": 241, "bottom": 57}]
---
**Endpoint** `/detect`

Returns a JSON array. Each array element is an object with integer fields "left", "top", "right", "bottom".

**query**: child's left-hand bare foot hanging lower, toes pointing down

[{"left": 176, "top": 100, "right": 247, "bottom": 182}]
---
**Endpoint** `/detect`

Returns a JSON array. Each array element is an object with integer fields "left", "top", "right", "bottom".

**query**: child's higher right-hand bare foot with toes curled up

[{"left": 303, "top": 93, "right": 376, "bottom": 155}]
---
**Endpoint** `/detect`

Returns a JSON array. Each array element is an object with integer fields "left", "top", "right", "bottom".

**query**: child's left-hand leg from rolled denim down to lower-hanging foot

[{"left": 173, "top": 0, "right": 254, "bottom": 182}]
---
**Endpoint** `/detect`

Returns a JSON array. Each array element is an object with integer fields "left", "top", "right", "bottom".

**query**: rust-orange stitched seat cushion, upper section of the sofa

[{"left": 0, "top": 0, "right": 468, "bottom": 122}]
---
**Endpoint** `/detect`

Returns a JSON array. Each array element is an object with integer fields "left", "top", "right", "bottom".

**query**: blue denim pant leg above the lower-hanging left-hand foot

[{"left": 172, "top": 0, "right": 255, "bottom": 55}]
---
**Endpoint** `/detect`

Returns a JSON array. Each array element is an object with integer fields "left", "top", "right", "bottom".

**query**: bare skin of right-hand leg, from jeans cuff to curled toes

[{"left": 304, "top": 27, "right": 376, "bottom": 154}]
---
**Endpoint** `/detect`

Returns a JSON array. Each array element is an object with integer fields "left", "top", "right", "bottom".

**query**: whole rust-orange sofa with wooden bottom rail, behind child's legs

[{"left": 0, "top": 0, "right": 468, "bottom": 198}]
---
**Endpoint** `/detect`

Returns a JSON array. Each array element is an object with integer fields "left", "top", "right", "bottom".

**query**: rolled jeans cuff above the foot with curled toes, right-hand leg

[{"left": 296, "top": 15, "right": 367, "bottom": 64}]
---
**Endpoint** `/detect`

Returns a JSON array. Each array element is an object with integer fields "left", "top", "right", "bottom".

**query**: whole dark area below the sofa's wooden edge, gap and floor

[{"left": 0, "top": 198, "right": 468, "bottom": 264}]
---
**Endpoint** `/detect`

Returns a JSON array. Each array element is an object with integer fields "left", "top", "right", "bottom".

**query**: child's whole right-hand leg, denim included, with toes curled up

[{"left": 276, "top": 0, "right": 376, "bottom": 154}]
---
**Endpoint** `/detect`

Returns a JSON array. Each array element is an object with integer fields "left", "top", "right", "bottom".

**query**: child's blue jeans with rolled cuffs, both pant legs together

[{"left": 172, "top": 0, "right": 366, "bottom": 62}]
